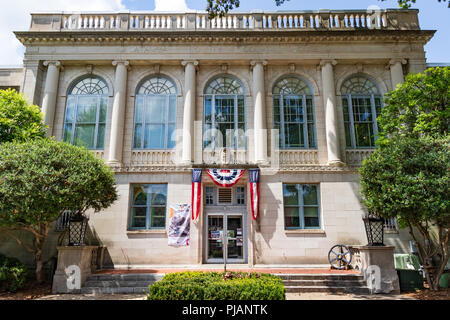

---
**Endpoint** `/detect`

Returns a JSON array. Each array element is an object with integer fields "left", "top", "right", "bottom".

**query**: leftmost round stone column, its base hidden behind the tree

[{"left": 42, "top": 61, "right": 61, "bottom": 136}]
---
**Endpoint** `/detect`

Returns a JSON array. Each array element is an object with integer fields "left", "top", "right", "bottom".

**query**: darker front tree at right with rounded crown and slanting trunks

[{"left": 359, "top": 136, "right": 450, "bottom": 290}]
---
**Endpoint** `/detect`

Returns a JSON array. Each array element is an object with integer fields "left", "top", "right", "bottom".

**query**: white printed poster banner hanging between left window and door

[{"left": 168, "top": 204, "right": 191, "bottom": 247}]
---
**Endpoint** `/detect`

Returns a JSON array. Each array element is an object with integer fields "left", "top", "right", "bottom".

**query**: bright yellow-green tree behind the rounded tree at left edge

[{"left": 0, "top": 89, "right": 47, "bottom": 144}]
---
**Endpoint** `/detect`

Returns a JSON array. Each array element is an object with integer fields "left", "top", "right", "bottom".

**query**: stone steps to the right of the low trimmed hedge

[{"left": 277, "top": 274, "right": 370, "bottom": 294}]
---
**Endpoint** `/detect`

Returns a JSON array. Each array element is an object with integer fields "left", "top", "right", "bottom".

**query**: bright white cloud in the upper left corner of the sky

[{"left": 0, "top": 0, "right": 125, "bottom": 65}]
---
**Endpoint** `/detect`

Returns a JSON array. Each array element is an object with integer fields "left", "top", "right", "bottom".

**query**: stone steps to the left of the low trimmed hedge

[{"left": 81, "top": 274, "right": 164, "bottom": 294}]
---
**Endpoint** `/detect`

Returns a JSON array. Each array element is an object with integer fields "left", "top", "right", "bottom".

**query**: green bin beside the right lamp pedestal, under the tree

[{"left": 394, "top": 254, "right": 423, "bottom": 291}]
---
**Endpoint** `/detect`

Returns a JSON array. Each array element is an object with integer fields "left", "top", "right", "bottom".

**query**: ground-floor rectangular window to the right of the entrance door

[{"left": 283, "top": 184, "right": 320, "bottom": 229}]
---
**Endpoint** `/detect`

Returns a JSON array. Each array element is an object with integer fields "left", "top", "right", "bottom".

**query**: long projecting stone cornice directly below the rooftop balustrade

[{"left": 15, "top": 30, "right": 436, "bottom": 45}]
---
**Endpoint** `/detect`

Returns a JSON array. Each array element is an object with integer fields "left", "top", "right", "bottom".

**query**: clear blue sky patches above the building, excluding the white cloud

[{"left": 123, "top": 0, "right": 450, "bottom": 62}]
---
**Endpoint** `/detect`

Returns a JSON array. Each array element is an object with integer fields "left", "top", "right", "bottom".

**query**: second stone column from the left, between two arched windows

[{"left": 108, "top": 61, "right": 129, "bottom": 165}]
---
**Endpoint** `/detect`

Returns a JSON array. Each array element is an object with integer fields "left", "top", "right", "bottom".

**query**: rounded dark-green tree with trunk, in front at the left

[{"left": 0, "top": 138, "right": 117, "bottom": 282}]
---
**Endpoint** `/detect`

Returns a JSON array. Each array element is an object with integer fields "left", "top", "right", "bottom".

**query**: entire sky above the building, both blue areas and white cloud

[{"left": 0, "top": 0, "right": 450, "bottom": 65}]
